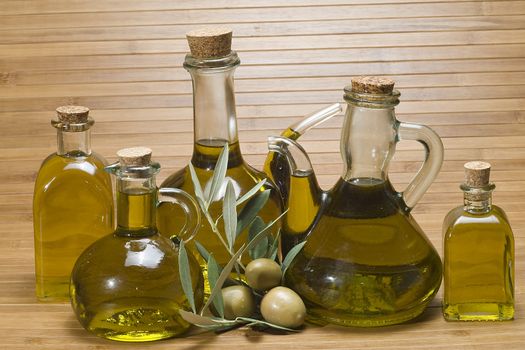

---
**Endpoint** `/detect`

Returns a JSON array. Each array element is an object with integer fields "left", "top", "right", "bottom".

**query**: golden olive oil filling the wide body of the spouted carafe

[{"left": 285, "top": 179, "right": 441, "bottom": 327}]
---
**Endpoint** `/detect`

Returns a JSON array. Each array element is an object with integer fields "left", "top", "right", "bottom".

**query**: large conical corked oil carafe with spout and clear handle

[{"left": 269, "top": 77, "right": 443, "bottom": 327}]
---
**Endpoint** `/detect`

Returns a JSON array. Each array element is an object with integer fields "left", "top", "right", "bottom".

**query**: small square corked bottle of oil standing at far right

[{"left": 443, "top": 162, "right": 514, "bottom": 321}]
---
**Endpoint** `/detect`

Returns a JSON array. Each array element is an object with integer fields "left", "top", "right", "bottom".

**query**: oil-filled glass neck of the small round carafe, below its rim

[{"left": 116, "top": 176, "right": 157, "bottom": 236}]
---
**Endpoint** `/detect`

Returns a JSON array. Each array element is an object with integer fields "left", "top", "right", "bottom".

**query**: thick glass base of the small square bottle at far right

[{"left": 443, "top": 303, "right": 514, "bottom": 321}]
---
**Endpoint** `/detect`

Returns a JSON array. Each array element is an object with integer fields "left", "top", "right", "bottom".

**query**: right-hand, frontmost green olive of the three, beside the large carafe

[{"left": 261, "top": 287, "right": 306, "bottom": 328}]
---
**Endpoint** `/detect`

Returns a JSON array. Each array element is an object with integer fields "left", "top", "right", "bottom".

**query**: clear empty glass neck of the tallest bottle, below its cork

[{"left": 185, "top": 59, "right": 238, "bottom": 147}]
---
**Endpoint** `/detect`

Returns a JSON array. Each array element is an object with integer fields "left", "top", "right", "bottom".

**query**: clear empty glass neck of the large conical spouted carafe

[{"left": 341, "top": 103, "right": 397, "bottom": 182}]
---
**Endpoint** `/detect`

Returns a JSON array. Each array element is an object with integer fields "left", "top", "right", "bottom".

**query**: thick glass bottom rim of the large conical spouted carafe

[{"left": 307, "top": 303, "right": 427, "bottom": 327}]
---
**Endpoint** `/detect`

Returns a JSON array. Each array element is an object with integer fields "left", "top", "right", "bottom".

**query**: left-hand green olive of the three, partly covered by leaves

[{"left": 222, "top": 286, "right": 255, "bottom": 320}]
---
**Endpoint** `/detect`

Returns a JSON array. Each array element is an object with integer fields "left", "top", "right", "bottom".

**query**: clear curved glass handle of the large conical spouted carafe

[{"left": 397, "top": 122, "right": 444, "bottom": 210}]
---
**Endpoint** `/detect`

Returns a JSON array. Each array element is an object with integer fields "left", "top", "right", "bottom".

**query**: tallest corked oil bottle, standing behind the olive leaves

[{"left": 158, "top": 28, "right": 281, "bottom": 276}]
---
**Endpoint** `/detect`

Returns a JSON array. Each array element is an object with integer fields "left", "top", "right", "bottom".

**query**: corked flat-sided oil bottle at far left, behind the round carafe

[{"left": 33, "top": 106, "right": 113, "bottom": 302}]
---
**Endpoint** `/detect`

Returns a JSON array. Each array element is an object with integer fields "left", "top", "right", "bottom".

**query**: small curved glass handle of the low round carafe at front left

[{"left": 157, "top": 187, "right": 201, "bottom": 242}]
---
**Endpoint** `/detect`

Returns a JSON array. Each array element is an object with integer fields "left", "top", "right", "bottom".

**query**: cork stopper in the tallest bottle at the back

[{"left": 186, "top": 27, "right": 232, "bottom": 58}]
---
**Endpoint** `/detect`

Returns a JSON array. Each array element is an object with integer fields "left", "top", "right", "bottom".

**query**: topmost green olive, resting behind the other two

[{"left": 245, "top": 258, "right": 282, "bottom": 291}]
